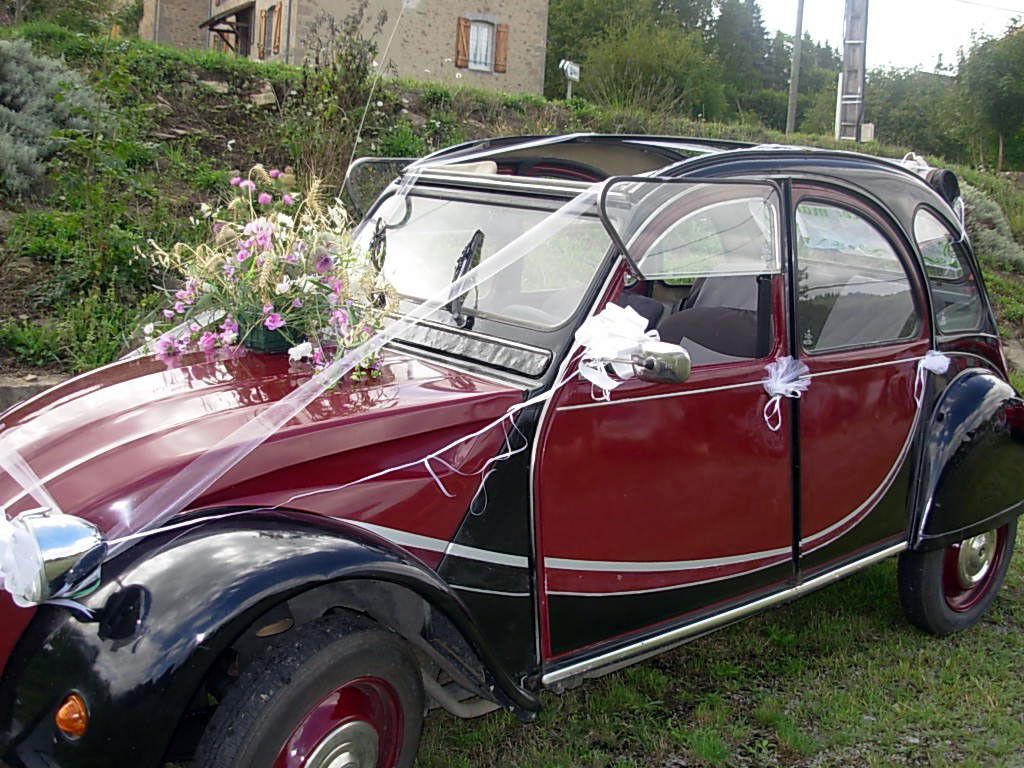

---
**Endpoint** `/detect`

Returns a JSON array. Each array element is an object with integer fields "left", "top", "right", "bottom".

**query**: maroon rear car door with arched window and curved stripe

[{"left": 794, "top": 184, "right": 930, "bottom": 575}]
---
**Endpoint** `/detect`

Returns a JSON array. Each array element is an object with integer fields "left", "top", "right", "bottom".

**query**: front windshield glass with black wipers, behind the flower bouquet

[{"left": 358, "top": 190, "right": 610, "bottom": 330}]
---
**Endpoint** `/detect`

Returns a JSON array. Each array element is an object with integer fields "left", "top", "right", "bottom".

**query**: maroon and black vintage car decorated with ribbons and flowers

[{"left": 0, "top": 135, "right": 1024, "bottom": 768}]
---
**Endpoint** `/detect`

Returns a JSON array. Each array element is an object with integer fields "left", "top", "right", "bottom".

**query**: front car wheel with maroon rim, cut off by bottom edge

[{"left": 191, "top": 615, "right": 424, "bottom": 768}]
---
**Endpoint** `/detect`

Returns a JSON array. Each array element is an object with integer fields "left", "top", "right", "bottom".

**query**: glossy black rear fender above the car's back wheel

[{"left": 910, "top": 369, "right": 1024, "bottom": 549}]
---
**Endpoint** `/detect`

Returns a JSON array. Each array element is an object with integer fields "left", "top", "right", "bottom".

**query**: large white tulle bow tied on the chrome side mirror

[{"left": 575, "top": 304, "right": 658, "bottom": 400}]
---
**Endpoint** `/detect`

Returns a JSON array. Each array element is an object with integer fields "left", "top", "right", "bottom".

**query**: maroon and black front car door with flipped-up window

[{"left": 535, "top": 177, "right": 794, "bottom": 660}]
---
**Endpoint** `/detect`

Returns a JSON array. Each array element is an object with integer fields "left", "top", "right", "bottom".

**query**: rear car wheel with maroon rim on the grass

[{"left": 897, "top": 520, "right": 1017, "bottom": 636}]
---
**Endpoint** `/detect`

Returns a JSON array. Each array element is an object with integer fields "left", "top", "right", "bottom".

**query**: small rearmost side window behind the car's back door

[{"left": 913, "top": 209, "right": 984, "bottom": 333}]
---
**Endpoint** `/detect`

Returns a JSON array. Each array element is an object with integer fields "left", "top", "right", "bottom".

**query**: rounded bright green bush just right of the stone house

[{"left": 580, "top": 20, "right": 725, "bottom": 119}]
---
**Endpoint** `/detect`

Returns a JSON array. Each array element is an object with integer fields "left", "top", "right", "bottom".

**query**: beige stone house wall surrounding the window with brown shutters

[{"left": 291, "top": 0, "right": 548, "bottom": 93}]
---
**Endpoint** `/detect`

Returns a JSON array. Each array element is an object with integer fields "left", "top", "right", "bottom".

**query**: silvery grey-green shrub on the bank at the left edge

[{"left": 0, "top": 40, "right": 103, "bottom": 195}]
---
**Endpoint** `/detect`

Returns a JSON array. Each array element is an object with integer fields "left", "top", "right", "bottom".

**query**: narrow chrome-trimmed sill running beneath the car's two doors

[{"left": 541, "top": 542, "right": 907, "bottom": 687}]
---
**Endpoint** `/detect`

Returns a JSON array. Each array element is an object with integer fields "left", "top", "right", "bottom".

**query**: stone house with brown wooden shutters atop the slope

[{"left": 139, "top": 0, "right": 548, "bottom": 93}]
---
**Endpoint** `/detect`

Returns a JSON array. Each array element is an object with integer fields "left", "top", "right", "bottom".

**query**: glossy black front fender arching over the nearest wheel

[{"left": 0, "top": 512, "right": 539, "bottom": 768}]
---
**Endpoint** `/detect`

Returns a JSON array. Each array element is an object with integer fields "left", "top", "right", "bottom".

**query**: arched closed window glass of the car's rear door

[{"left": 796, "top": 202, "right": 920, "bottom": 351}]
